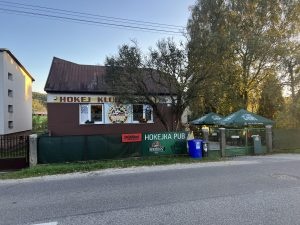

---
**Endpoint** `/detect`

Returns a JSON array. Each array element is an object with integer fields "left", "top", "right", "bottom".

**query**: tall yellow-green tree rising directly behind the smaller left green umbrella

[{"left": 188, "top": 0, "right": 239, "bottom": 114}]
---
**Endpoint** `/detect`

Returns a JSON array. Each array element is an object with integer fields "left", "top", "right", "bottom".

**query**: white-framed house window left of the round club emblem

[{"left": 79, "top": 104, "right": 103, "bottom": 124}]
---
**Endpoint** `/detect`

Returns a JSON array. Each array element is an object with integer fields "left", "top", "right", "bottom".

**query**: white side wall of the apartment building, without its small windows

[{"left": 0, "top": 52, "right": 32, "bottom": 134}]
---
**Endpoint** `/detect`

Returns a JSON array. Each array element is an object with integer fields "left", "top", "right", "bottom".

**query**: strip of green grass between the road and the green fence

[{"left": 0, "top": 155, "right": 221, "bottom": 179}]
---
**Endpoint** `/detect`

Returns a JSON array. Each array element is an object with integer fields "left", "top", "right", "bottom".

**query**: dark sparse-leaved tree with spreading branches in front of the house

[{"left": 106, "top": 39, "right": 200, "bottom": 131}]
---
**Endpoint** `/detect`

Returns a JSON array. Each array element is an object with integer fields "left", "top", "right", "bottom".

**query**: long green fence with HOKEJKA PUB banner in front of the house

[{"left": 38, "top": 132, "right": 187, "bottom": 163}]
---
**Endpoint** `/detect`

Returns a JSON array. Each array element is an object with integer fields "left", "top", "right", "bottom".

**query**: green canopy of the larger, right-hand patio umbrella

[{"left": 220, "top": 109, "right": 274, "bottom": 127}]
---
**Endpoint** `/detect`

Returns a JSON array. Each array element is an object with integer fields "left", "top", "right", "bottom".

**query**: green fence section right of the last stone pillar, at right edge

[{"left": 273, "top": 128, "right": 300, "bottom": 150}]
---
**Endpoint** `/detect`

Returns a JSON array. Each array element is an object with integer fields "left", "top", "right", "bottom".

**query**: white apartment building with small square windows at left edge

[{"left": 0, "top": 48, "right": 34, "bottom": 135}]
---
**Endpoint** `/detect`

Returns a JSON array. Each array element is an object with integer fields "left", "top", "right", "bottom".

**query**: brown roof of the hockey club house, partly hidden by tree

[{"left": 44, "top": 57, "right": 170, "bottom": 94}]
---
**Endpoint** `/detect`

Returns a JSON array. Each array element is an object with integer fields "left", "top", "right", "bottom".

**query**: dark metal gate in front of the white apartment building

[{"left": 0, "top": 136, "right": 29, "bottom": 170}]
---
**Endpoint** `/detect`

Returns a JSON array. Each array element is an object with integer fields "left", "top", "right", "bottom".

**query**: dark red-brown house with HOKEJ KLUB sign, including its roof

[{"left": 44, "top": 57, "right": 174, "bottom": 136}]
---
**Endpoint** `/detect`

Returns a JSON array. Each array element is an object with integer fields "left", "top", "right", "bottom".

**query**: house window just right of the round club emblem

[{"left": 132, "top": 104, "right": 153, "bottom": 123}]
